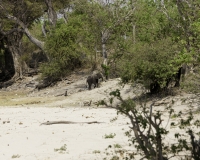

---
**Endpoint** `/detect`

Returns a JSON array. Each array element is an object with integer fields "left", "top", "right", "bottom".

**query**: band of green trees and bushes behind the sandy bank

[{"left": 0, "top": 0, "right": 200, "bottom": 92}]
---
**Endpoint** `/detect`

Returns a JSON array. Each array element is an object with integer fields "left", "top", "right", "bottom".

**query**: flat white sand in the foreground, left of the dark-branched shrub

[{"left": 0, "top": 107, "right": 133, "bottom": 160}]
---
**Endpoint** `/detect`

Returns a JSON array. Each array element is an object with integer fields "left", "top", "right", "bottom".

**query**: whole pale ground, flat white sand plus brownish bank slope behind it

[{"left": 0, "top": 71, "right": 200, "bottom": 160}]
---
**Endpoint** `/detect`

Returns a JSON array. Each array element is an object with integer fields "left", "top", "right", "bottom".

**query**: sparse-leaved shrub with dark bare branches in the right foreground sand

[{"left": 101, "top": 90, "right": 200, "bottom": 160}]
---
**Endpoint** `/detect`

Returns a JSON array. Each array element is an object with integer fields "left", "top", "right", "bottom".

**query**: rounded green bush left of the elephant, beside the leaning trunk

[{"left": 40, "top": 20, "right": 84, "bottom": 79}]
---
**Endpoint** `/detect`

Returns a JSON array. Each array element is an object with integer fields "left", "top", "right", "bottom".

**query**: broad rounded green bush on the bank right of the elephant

[{"left": 120, "top": 38, "right": 190, "bottom": 93}]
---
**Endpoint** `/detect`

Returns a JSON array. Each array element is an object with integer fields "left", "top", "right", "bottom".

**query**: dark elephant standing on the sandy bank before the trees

[{"left": 86, "top": 73, "right": 103, "bottom": 90}]
